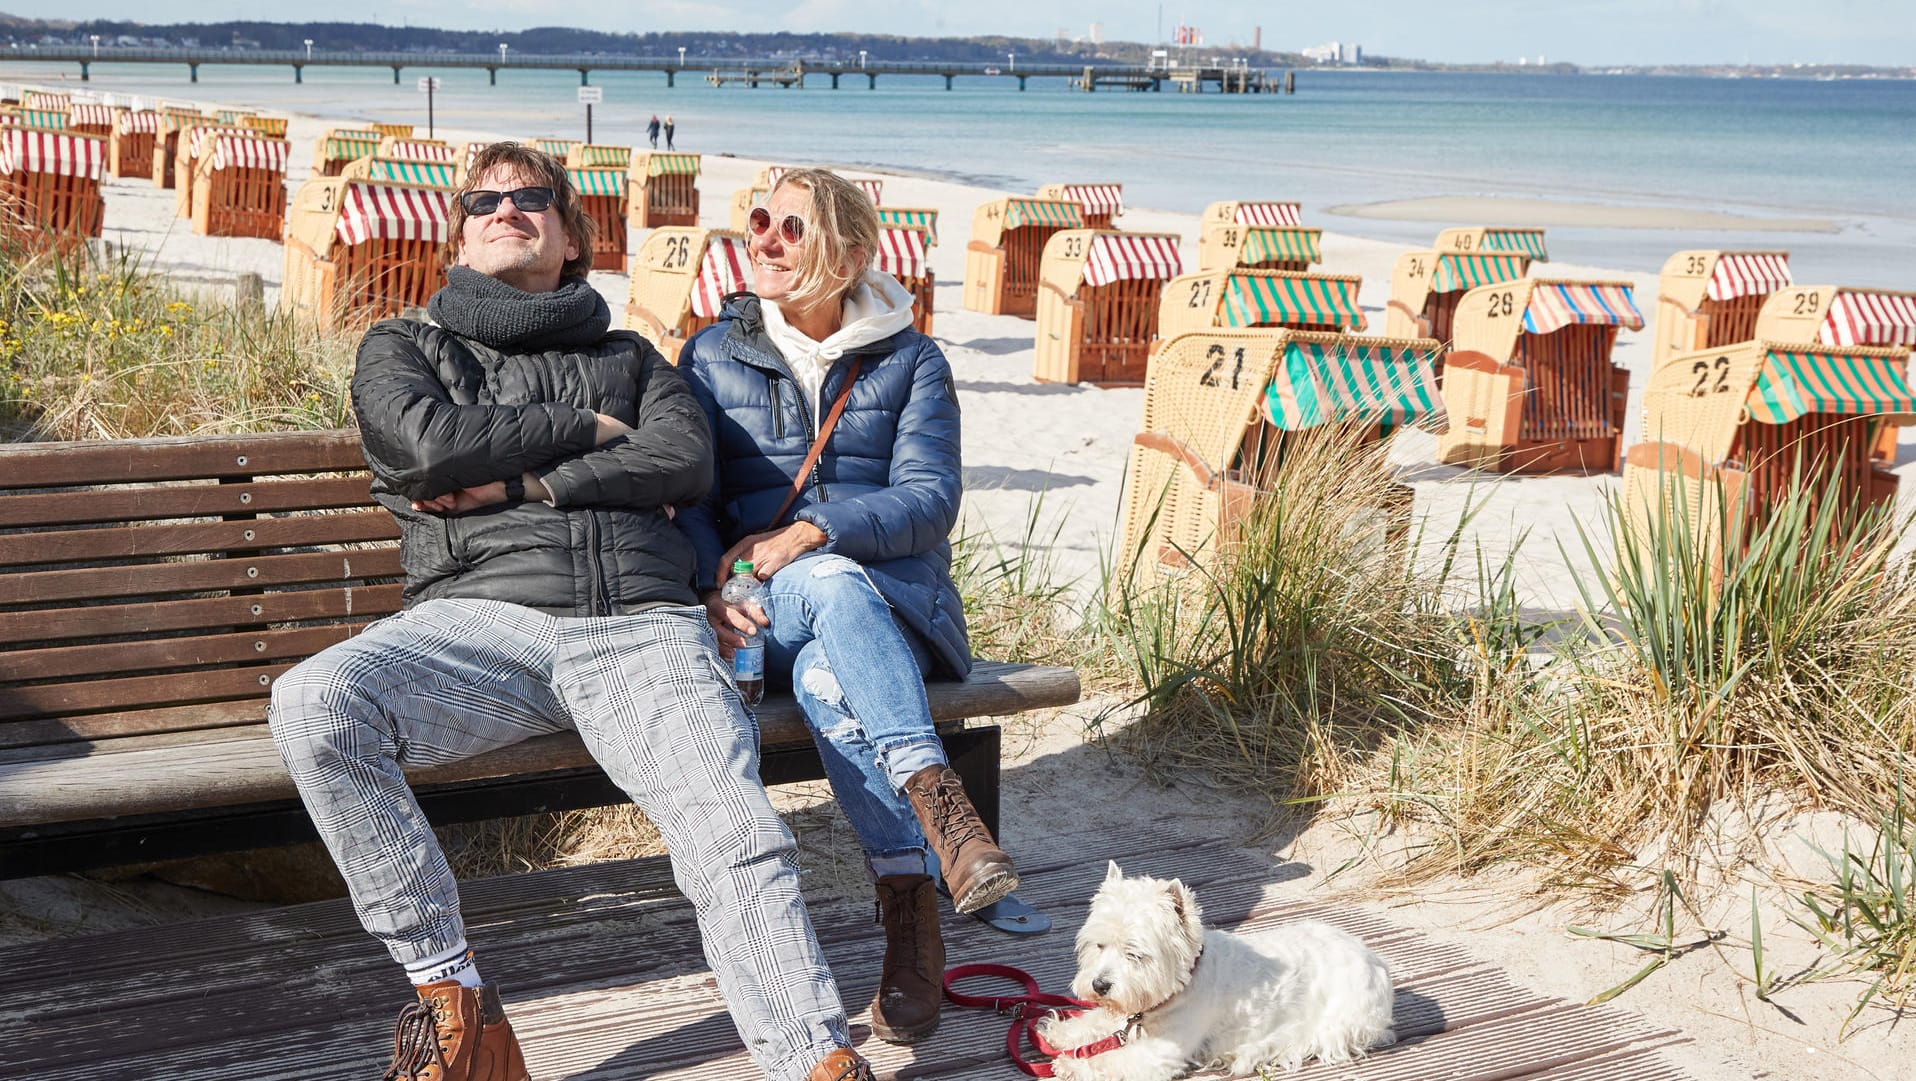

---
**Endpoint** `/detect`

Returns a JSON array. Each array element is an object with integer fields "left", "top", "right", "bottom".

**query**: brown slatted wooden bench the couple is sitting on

[{"left": 0, "top": 431, "right": 1079, "bottom": 878}]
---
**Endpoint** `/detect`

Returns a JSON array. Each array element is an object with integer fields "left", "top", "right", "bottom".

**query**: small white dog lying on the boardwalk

[{"left": 1038, "top": 863, "right": 1397, "bottom": 1081}]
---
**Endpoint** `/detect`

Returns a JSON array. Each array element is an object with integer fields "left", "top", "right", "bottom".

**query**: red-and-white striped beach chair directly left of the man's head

[{"left": 280, "top": 176, "right": 452, "bottom": 326}]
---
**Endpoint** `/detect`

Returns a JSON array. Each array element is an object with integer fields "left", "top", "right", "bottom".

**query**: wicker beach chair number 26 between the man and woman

[{"left": 625, "top": 226, "right": 751, "bottom": 364}]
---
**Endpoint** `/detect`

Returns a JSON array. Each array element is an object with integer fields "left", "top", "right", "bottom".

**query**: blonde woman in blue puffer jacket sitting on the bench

[{"left": 682, "top": 168, "right": 1017, "bottom": 1043}]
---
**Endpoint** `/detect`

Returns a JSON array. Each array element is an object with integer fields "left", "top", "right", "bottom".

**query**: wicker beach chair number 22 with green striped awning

[{"left": 1623, "top": 339, "right": 1916, "bottom": 571}]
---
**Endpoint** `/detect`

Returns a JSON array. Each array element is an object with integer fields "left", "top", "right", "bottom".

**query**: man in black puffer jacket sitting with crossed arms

[{"left": 270, "top": 142, "right": 872, "bottom": 1081}]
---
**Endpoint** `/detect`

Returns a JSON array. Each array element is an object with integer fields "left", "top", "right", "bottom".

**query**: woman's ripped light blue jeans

[{"left": 764, "top": 554, "right": 947, "bottom": 866}]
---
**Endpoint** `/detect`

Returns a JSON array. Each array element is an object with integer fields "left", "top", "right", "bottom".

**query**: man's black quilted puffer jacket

[{"left": 353, "top": 320, "right": 713, "bottom": 615}]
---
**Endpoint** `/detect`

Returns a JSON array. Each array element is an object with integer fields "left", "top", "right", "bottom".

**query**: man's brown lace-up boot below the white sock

[{"left": 385, "top": 979, "right": 531, "bottom": 1081}]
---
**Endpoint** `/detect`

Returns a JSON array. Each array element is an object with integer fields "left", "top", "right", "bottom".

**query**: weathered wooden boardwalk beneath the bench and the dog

[{"left": 0, "top": 830, "right": 1684, "bottom": 1081}]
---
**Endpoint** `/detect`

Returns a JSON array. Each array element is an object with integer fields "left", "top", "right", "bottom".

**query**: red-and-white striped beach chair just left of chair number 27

[{"left": 1033, "top": 228, "right": 1184, "bottom": 387}]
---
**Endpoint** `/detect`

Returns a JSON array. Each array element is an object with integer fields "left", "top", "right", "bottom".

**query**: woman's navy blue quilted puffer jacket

[{"left": 678, "top": 293, "right": 971, "bottom": 677}]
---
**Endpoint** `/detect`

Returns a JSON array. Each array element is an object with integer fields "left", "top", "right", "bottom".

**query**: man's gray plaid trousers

[{"left": 270, "top": 600, "right": 851, "bottom": 1081}]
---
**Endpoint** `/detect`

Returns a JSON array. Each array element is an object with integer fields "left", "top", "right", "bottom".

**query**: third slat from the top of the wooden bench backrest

[{"left": 0, "top": 508, "right": 399, "bottom": 567}]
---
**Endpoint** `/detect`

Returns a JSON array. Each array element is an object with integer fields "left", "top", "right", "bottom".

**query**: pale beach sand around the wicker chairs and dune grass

[{"left": 0, "top": 80, "right": 1916, "bottom": 1081}]
